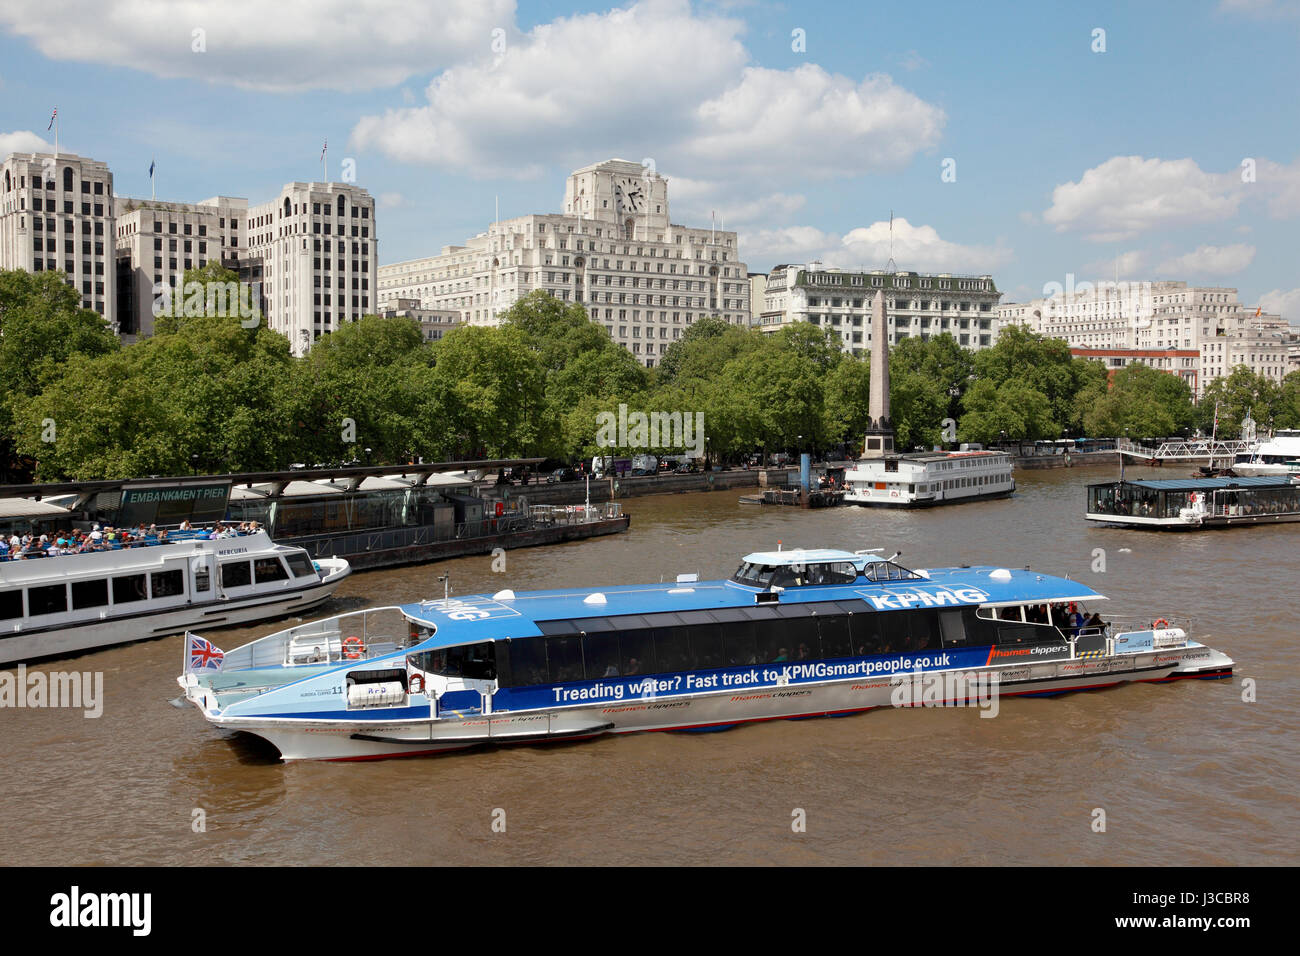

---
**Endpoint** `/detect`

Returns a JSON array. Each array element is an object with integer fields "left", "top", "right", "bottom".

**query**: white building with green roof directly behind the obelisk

[{"left": 758, "top": 264, "right": 1002, "bottom": 354}]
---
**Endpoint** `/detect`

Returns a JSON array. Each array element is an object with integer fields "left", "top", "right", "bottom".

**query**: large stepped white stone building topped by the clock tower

[{"left": 378, "top": 160, "right": 750, "bottom": 367}]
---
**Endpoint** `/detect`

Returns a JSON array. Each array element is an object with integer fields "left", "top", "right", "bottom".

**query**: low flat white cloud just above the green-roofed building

[{"left": 740, "top": 217, "right": 1015, "bottom": 274}]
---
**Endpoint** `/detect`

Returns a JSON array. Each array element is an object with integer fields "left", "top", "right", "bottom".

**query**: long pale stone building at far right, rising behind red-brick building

[{"left": 997, "top": 281, "right": 1292, "bottom": 399}]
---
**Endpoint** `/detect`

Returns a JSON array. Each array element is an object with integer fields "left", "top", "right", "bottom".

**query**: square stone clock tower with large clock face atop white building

[{"left": 564, "top": 159, "right": 668, "bottom": 241}]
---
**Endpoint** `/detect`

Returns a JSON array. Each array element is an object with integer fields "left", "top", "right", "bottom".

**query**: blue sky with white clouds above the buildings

[{"left": 0, "top": 0, "right": 1300, "bottom": 324}]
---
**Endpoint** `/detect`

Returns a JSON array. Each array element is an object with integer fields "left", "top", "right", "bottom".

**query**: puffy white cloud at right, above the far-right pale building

[{"left": 1043, "top": 156, "right": 1242, "bottom": 242}]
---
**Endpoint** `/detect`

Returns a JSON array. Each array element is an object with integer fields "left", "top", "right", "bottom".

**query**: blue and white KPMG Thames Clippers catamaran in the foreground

[{"left": 178, "top": 550, "right": 1232, "bottom": 760}]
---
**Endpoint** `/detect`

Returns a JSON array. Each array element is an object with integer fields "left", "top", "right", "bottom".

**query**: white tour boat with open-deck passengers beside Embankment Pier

[{"left": 0, "top": 531, "right": 351, "bottom": 665}]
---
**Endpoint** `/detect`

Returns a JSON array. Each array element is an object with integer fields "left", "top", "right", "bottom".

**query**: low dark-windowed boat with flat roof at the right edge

[{"left": 1084, "top": 476, "right": 1300, "bottom": 529}]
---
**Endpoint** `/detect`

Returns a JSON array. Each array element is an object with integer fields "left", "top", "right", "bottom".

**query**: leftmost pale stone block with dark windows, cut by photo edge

[{"left": 0, "top": 152, "right": 116, "bottom": 324}]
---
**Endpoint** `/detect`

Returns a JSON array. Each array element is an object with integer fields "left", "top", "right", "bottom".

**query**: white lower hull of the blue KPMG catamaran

[{"left": 195, "top": 644, "right": 1234, "bottom": 761}]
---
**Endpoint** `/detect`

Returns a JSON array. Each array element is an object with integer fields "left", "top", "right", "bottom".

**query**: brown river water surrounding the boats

[{"left": 0, "top": 467, "right": 1300, "bottom": 865}]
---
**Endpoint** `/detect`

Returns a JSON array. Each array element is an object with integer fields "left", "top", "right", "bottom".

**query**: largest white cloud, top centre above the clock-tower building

[{"left": 352, "top": 0, "right": 945, "bottom": 180}]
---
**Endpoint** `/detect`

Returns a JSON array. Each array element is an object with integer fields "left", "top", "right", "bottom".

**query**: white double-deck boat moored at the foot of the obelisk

[{"left": 844, "top": 451, "right": 1015, "bottom": 507}]
